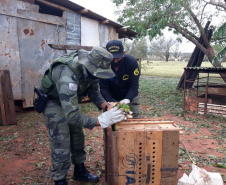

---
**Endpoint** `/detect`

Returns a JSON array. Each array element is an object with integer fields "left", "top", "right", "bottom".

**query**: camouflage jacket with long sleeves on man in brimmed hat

[{"left": 50, "top": 57, "right": 105, "bottom": 129}]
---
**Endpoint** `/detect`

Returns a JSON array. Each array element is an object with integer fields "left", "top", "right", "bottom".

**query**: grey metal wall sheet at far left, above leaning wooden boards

[{"left": 0, "top": 15, "right": 22, "bottom": 100}]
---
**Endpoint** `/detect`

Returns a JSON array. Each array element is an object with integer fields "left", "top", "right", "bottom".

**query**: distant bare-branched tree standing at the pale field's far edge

[{"left": 151, "top": 37, "right": 177, "bottom": 62}]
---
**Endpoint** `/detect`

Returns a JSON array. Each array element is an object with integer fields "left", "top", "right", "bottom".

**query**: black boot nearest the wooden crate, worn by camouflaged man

[{"left": 74, "top": 163, "right": 99, "bottom": 182}]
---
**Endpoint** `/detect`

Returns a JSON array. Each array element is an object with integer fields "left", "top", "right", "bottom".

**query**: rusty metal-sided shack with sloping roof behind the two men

[{"left": 0, "top": 0, "right": 136, "bottom": 108}]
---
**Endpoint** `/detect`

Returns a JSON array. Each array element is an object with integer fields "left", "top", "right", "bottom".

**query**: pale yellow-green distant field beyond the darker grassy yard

[{"left": 141, "top": 61, "right": 226, "bottom": 77}]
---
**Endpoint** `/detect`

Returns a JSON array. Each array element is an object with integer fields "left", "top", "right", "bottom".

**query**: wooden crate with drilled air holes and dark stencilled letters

[{"left": 104, "top": 118, "right": 182, "bottom": 185}]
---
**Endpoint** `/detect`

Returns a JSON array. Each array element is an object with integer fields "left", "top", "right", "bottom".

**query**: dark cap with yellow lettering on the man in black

[{"left": 106, "top": 40, "right": 124, "bottom": 58}]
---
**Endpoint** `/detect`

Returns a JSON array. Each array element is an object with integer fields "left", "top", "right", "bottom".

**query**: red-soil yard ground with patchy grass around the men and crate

[{"left": 0, "top": 75, "right": 226, "bottom": 185}]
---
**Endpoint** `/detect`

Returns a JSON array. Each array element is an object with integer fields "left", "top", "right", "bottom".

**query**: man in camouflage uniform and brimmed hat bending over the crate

[{"left": 40, "top": 47, "right": 125, "bottom": 185}]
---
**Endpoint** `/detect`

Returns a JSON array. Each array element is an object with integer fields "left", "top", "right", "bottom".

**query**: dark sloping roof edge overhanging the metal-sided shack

[{"left": 36, "top": 0, "right": 137, "bottom": 38}]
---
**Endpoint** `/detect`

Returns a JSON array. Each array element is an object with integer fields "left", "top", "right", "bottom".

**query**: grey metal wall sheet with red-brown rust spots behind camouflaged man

[{"left": 18, "top": 15, "right": 66, "bottom": 107}]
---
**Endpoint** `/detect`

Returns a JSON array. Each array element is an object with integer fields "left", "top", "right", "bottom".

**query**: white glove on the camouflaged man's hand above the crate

[{"left": 97, "top": 106, "right": 125, "bottom": 128}]
